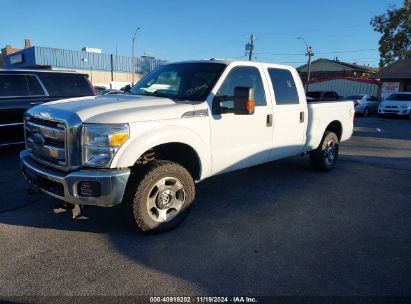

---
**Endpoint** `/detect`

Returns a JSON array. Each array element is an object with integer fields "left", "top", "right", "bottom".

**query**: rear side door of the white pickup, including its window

[{"left": 267, "top": 68, "right": 308, "bottom": 160}]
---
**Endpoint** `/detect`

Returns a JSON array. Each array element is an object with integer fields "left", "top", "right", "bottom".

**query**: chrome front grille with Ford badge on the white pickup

[{"left": 25, "top": 116, "right": 68, "bottom": 167}]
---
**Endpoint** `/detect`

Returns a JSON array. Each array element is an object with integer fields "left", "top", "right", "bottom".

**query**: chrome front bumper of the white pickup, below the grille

[{"left": 20, "top": 150, "right": 130, "bottom": 207}]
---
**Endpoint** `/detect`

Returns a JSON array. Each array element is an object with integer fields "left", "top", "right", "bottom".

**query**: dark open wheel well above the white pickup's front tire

[{"left": 136, "top": 143, "right": 201, "bottom": 180}]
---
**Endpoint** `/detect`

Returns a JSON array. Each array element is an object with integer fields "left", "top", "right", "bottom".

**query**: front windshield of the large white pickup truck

[{"left": 128, "top": 62, "right": 226, "bottom": 102}]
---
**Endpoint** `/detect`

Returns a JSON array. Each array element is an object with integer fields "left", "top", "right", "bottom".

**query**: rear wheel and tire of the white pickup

[{"left": 310, "top": 131, "right": 338, "bottom": 172}]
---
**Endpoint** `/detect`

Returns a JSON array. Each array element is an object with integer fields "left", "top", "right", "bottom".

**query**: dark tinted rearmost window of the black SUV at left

[{"left": 38, "top": 73, "right": 94, "bottom": 97}]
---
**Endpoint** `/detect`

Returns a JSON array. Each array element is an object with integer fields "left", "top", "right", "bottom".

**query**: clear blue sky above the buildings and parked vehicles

[{"left": 0, "top": 0, "right": 403, "bottom": 66}]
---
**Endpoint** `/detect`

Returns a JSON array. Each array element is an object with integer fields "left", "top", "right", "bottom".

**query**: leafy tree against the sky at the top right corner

[{"left": 370, "top": 0, "right": 411, "bottom": 68}]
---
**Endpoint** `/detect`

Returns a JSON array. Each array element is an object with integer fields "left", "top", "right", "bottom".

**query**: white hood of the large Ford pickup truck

[{"left": 34, "top": 95, "right": 194, "bottom": 123}]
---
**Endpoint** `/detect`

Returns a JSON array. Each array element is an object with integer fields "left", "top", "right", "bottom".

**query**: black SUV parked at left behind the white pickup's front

[{"left": 0, "top": 69, "right": 97, "bottom": 147}]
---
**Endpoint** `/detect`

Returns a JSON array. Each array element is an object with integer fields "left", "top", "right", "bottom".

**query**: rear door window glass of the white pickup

[{"left": 268, "top": 69, "right": 300, "bottom": 105}]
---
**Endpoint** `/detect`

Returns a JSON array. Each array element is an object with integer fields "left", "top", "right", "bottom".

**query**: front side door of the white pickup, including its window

[{"left": 210, "top": 66, "right": 273, "bottom": 174}]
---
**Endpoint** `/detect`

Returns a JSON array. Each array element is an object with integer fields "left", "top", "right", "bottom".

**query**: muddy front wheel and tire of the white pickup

[{"left": 125, "top": 160, "right": 195, "bottom": 233}]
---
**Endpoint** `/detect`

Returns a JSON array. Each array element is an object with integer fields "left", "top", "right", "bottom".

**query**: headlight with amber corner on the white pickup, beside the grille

[{"left": 83, "top": 124, "right": 130, "bottom": 167}]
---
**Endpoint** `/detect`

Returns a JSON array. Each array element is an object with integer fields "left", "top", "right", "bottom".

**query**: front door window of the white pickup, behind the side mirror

[{"left": 216, "top": 67, "right": 267, "bottom": 113}]
